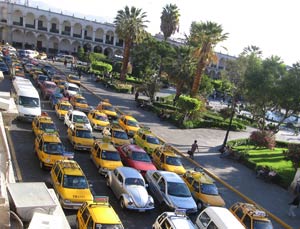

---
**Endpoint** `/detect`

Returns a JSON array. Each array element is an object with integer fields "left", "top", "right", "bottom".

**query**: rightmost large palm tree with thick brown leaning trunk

[{"left": 187, "top": 21, "right": 228, "bottom": 97}]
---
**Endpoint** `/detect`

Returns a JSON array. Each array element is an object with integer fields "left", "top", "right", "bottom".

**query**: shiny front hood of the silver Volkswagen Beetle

[{"left": 126, "top": 185, "right": 149, "bottom": 207}]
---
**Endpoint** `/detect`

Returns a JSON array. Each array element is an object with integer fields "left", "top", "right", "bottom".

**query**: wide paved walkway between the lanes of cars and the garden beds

[{"left": 64, "top": 68, "right": 300, "bottom": 229}]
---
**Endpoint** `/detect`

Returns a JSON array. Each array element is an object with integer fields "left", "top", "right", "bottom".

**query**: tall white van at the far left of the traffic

[{"left": 12, "top": 77, "right": 41, "bottom": 121}]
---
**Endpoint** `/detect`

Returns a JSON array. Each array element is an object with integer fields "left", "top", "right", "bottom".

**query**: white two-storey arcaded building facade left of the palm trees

[{"left": 0, "top": 1, "right": 124, "bottom": 57}]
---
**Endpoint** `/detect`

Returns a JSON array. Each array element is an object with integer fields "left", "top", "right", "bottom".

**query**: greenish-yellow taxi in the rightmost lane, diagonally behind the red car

[{"left": 133, "top": 127, "right": 162, "bottom": 156}]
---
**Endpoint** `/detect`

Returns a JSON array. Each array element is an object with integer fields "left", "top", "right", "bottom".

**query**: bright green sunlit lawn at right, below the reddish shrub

[{"left": 233, "top": 145, "right": 296, "bottom": 188}]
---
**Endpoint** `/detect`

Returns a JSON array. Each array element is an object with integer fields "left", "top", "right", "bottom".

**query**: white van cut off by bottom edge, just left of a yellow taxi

[{"left": 196, "top": 207, "right": 245, "bottom": 229}]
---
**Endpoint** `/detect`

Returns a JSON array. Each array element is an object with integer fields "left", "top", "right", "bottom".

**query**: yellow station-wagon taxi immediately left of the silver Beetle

[{"left": 50, "top": 160, "right": 93, "bottom": 209}]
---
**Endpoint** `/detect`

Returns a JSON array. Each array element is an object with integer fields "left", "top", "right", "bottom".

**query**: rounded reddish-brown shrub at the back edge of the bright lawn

[{"left": 250, "top": 130, "right": 276, "bottom": 149}]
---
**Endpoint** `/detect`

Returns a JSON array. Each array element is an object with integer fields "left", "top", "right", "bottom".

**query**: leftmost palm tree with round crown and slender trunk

[{"left": 114, "top": 6, "right": 148, "bottom": 81}]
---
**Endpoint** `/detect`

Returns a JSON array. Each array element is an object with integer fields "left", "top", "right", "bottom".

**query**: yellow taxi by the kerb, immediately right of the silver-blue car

[{"left": 182, "top": 168, "right": 225, "bottom": 210}]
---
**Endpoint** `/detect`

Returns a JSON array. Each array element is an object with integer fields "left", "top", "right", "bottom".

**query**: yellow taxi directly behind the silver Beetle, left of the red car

[{"left": 90, "top": 140, "right": 123, "bottom": 174}]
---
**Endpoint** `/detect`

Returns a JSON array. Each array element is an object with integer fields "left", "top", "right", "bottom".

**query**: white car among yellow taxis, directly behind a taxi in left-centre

[{"left": 64, "top": 110, "right": 93, "bottom": 131}]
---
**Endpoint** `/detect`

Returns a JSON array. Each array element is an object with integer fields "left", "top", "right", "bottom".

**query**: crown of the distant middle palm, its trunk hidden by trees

[{"left": 160, "top": 4, "right": 180, "bottom": 41}]
